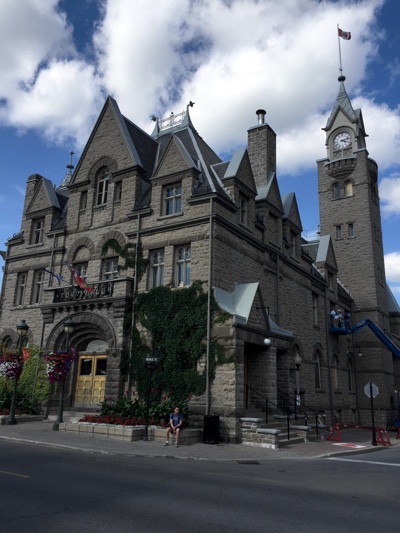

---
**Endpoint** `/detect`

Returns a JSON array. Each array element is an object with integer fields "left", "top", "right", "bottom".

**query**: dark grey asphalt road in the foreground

[{"left": 0, "top": 442, "right": 400, "bottom": 533}]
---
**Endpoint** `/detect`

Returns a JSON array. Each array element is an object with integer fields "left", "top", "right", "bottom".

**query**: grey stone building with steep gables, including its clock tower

[{"left": 0, "top": 77, "right": 400, "bottom": 440}]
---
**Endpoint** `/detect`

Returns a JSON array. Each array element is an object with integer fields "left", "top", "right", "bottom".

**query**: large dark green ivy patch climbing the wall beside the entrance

[{"left": 126, "top": 281, "right": 221, "bottom": 404}]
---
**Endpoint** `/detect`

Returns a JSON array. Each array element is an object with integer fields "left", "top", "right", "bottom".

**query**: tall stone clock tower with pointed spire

[{"left": 317, "top": 76, "right": 394, "bottom": 424}]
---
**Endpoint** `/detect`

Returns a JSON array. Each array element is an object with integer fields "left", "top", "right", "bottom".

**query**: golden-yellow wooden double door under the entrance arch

[{"left": 75, "top": 355, "right": 107, "bottom": 405}]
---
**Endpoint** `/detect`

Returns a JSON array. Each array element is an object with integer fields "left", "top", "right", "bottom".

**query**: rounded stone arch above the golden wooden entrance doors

[{"left": 46, "top": 311, "right": 117, "bottom": 353}]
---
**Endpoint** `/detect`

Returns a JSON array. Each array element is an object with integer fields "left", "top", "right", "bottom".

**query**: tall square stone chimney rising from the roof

[{"left": 247, "top": 109, "right": 276, "bottom": 187}]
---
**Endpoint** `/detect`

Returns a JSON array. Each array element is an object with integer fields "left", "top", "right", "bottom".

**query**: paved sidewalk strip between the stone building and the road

[{"left": 0, "top": 420, "right": 400, "bottom": 461}]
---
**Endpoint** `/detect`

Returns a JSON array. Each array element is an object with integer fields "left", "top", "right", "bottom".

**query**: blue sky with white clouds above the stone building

[{"left": 0, "top": 0, "right": 400, "bottom": 301}]
